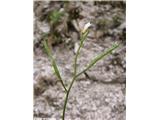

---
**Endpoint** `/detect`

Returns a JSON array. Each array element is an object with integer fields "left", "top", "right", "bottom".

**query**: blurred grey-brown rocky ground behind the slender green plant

[{"left": 34, "top": 1, "right": 126, "bottom": 120}]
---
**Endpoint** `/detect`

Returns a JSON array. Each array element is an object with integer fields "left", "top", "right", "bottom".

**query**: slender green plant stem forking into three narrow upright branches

[{"left": 44, "top": 28, "right": 119, "bottom": 120}]
